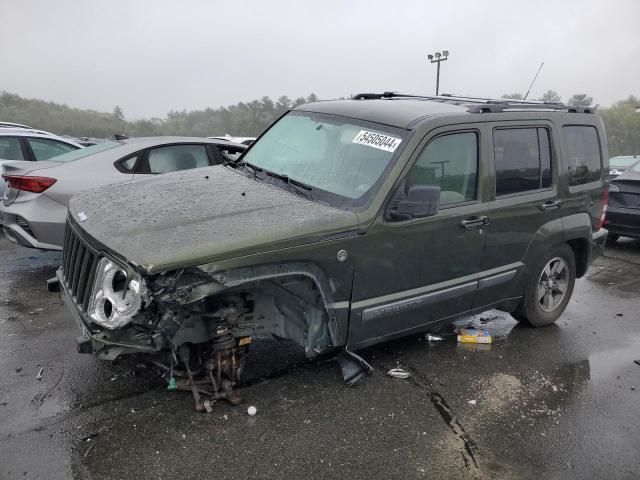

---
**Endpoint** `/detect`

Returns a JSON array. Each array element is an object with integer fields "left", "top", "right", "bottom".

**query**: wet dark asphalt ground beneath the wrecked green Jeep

[{"left": 0, "top": 239, "right": 640, "bottom": 479}]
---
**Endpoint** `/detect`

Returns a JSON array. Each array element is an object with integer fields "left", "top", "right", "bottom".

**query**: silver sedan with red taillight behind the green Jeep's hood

[{"left": 0, "top": 137, "right": 247, "bottom": 250}]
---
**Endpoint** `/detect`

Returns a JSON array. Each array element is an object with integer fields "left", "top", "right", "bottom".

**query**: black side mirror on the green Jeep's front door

[{"left": 386, "top": 184, "right": 440, "bottom": 220}]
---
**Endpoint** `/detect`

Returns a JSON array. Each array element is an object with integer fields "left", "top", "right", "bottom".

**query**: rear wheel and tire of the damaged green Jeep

[{"left": 511, "top": 243, "right": 576, "bottom": 328}]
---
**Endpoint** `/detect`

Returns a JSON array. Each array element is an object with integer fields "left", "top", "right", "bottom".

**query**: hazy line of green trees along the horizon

[{"left": 0, "top": 90, "right": 640, "bottom": 156}]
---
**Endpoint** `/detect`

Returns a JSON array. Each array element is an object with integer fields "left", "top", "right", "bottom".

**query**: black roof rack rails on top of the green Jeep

[{"left": 352, "top": 92, "right": 596, "bottom": 113}]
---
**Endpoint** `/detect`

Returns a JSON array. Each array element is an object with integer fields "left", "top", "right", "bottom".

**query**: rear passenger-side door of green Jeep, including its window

[{"left": 474, "top": 121, "right": 565, "bottom": 308}]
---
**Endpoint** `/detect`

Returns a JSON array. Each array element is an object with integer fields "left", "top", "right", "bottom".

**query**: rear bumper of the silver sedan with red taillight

[{"left": 0, "top": 195, "right": 67, "bottom": 250}]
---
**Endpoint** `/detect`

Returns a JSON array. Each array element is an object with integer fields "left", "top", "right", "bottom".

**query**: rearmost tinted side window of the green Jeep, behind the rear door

[{"left": 562, "top": 126, "right": 602, "bottom": 185}]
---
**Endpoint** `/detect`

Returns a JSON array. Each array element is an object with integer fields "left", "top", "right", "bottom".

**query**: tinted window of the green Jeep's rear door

[{"left": 493, "top": 128, "right": 551, "bottom": 196}]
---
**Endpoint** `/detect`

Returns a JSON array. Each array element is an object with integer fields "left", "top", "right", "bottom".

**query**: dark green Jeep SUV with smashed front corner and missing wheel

[{"left": 50, "top": 93, "right": 608, "bottom": 409}]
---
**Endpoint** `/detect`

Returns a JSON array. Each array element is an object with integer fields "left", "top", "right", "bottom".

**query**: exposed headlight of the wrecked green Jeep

[{"left": 88, "top": 258, "right": 147, "bottom": 329}]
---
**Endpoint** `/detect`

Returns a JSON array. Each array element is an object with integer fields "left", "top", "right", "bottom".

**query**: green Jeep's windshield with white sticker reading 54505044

[{"left": 242, "top": 112, "right": 406, "bottom": 207}]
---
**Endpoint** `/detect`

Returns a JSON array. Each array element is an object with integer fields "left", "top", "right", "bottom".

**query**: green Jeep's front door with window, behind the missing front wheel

[{"left": 349, "top": 126, "right": 488, "bottom": 348}]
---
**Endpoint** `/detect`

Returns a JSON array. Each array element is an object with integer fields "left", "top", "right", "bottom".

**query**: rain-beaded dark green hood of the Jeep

[{"left": 69, "top": 166, "right": 358, "bottom": 273}]
